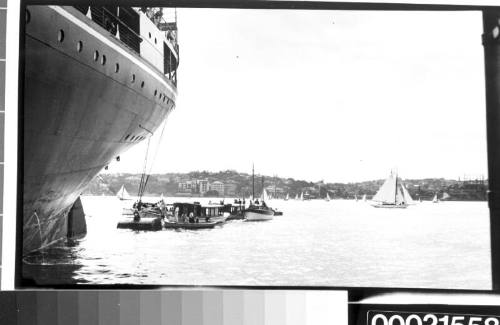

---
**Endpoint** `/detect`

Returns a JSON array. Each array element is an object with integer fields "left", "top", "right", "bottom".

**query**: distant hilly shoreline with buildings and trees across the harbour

[{"left": 83, "top": 170, "right": 488, "bottom": 201}]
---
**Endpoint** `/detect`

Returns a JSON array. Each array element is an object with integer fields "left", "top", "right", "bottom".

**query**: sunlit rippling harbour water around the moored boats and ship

[{"left": 23, "top": 196, "right": 491, "bottom": 289}]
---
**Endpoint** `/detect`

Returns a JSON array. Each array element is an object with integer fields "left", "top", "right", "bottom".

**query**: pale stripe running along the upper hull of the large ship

[{"left": 49, "top": 6, "right": 177, "bottom": 96}]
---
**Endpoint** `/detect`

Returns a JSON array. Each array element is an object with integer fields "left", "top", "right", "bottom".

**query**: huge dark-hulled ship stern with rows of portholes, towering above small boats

[{"left": 20, "top": 5, "right": 179, "bottom": 254}]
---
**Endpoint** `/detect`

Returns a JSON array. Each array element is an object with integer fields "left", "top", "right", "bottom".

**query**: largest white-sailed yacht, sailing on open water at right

[{"left": 372, "top": 172, "right": 413, "bottom": 209}]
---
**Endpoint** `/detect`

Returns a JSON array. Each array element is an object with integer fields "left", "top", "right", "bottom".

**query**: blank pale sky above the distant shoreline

[{"left": 107, "top": 8, "right": 487, "bottom": 182}]
